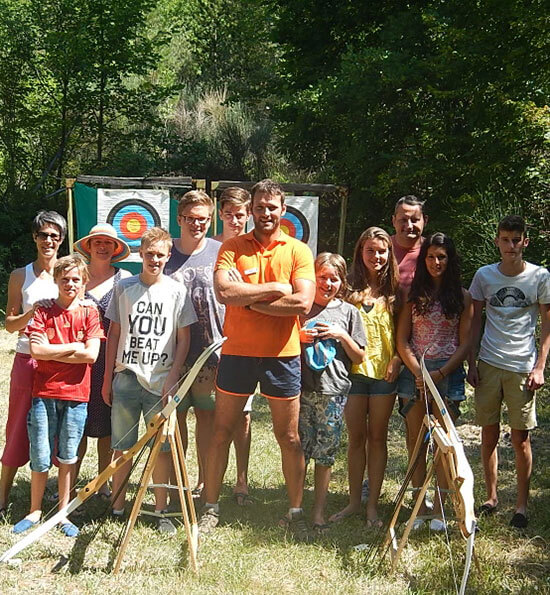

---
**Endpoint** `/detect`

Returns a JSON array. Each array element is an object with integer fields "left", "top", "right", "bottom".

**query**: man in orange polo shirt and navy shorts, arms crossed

[{"left": 200, "top": 180, "right": 315, "bottom": 538}]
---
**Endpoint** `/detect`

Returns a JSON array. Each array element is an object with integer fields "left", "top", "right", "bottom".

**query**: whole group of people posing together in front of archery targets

[{"left": 0, "top": 180, "right": 550, "bottom": 540}]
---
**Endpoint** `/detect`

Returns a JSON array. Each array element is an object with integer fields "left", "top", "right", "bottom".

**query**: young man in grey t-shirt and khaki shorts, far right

[{"left": 468, "top": 215, "right": 550, "bottom": 528}]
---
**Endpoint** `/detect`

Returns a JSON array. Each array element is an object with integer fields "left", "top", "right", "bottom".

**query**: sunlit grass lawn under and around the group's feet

[{"left": 0, "top": 330, "right": 550, "bottom": 595}]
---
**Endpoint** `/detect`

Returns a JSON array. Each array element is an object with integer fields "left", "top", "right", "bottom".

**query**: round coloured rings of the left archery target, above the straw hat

[{"left": 107, "top": 198, "right": 161, "bottom": 252}]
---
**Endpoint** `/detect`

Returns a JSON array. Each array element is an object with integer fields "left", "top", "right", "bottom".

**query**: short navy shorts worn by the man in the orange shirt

[{"left": 216, "top": 355, "right": 302, "bottom": 399}]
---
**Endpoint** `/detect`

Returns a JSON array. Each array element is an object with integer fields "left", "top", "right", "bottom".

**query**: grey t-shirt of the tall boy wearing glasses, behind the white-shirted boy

[{"left": 164, "top": 238, "right": 225, "bottom": 366}]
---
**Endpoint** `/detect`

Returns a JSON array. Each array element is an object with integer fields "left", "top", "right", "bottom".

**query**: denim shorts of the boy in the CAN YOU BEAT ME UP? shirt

[{"left": 111, "top": 370, "right": 170, "bottom": 452}]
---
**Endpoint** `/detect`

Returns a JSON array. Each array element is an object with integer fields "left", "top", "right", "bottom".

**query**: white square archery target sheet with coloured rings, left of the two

[{"left": 97, "top": 188, "right": 170, "bottom": 262}]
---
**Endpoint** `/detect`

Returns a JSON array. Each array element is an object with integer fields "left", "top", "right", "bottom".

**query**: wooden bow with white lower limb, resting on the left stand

[{"left": 0, "top": 338, "right": 225, "bottom": 562}]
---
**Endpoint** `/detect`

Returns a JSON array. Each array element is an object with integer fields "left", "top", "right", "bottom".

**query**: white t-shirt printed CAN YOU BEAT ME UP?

[{"left": 105, "top": 275, "right": 197, "bottom": 396}]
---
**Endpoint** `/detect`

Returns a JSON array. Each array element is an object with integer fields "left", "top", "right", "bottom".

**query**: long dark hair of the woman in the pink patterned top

[{"left": 409, "top": 232, "right": 464, "bottom": 318}]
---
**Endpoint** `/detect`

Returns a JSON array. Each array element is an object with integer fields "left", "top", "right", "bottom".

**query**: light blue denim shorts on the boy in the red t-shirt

[{"left": 27, "top": 397, "right": 88, "bottom": 473}]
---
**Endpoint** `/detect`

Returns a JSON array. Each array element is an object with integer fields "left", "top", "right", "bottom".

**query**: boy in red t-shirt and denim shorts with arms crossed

[{"left": 13, "top": 254, "right": 105, "bottom": 537}]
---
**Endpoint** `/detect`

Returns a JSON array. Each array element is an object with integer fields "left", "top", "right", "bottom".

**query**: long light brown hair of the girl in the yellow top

[{"left": 348, "top": 227, "right": 399, "bottom": 312}]
